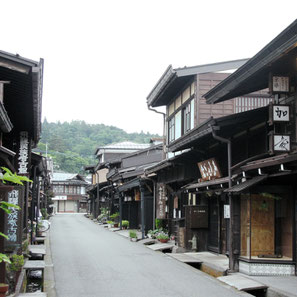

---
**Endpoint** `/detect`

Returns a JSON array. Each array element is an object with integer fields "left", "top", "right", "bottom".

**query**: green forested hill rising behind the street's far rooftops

[{"left": 36, "top": 119, "right": 160, "bottom": 173}]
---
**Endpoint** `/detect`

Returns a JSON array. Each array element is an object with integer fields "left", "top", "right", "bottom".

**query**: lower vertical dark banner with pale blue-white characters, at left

[{"left": 4, "top": 186, "right": 24, "bottom": 251}]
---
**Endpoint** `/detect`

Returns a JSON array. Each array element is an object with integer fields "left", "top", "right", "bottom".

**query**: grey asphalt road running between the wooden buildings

[{"left": 50, "top": 214, "right": 245, "bottom": 297}]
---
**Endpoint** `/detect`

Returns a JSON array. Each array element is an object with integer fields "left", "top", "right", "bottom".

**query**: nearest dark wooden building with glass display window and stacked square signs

[{"left": 201, "top": 21, "right": 297, "bottom": 275}]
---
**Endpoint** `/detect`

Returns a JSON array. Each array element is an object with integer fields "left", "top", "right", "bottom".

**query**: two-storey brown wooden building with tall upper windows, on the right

[{"left": 146, "top": 59, "right": 271, "bottom": 252}]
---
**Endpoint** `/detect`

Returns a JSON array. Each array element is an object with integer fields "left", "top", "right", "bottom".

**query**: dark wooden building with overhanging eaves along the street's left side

[{"left": 0, "top": 51, "right": 43, "bottom": 282}]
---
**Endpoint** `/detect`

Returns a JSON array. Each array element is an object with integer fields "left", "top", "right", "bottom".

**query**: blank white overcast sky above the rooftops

[{"left": 0, "top": 0, "right": 297, "bottom": 134}]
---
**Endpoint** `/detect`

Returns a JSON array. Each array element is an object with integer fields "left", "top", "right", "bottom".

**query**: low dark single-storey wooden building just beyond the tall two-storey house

[{"left": 109, "top": 144, "right": 163, "bottom": 237}]
